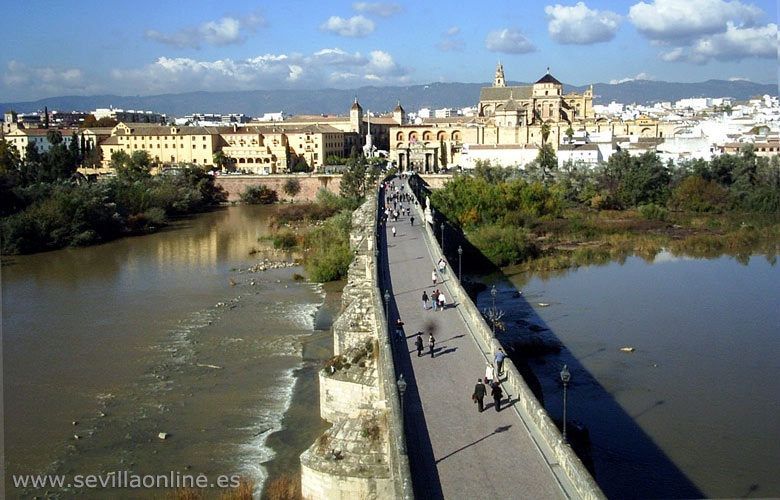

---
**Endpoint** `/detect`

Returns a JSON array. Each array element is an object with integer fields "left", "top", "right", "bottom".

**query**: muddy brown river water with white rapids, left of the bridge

[{"left": 2, "top": 206, "right": 340, "bottom": 498}]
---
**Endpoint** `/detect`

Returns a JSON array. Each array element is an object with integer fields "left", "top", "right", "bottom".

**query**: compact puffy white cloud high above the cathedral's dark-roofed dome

[{"left": 544, "top": 2, "right": 622, "bottom": 45}]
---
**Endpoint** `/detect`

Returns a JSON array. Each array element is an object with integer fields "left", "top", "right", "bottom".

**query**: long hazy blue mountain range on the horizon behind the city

[{"left": 0, "top": 80, "right": 778, "bottom": 117}]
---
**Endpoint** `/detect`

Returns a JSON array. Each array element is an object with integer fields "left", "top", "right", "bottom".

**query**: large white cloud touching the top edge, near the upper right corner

[{"left": 628, "top": 0, "right": 765, "bottom": 41}]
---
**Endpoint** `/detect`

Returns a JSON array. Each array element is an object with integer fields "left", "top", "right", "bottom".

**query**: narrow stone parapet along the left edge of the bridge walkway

[{"left": 371, "top": 184, "right": 414, "bottom": 500}]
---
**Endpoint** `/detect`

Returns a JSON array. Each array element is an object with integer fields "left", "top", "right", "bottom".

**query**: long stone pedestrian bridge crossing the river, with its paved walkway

[{"left": 301, "top": 178, "right": 604, "bottom": 500}]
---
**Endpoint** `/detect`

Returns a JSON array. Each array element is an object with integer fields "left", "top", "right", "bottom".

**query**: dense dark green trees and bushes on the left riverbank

[{"left": 0, "top": 139, "right": 226, "bottom": 254}]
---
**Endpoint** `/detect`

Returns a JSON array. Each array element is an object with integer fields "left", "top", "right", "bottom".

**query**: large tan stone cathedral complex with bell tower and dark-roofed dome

[{"left": 389, "top": 62, "right": 672, "bottom": 172}]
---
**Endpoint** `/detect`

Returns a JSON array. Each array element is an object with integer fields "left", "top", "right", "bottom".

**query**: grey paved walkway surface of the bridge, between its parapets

[{"left": 380, "top": 178, "right": 567, "bottom": 500}]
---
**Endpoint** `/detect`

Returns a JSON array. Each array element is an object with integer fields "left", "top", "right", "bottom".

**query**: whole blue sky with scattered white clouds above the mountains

[{"left": 0, "top": 0, "right": 779, "bottom": 101}]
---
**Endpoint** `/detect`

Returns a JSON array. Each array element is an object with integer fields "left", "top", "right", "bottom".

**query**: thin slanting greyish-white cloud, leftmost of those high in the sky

[{"left": 146, "top": 11, "right": 266, "bottom": 49}]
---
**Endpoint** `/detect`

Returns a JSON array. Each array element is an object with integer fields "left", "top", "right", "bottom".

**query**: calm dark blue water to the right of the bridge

[{"left": 478, "top": 252, "right": 780, "bottom": 498}]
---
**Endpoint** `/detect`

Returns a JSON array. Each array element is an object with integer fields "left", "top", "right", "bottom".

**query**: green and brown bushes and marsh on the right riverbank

[{"left": 431, "top": 145, "right": 780, "bottom": 270}]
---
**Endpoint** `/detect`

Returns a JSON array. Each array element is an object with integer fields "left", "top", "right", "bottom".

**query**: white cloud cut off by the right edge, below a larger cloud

[{"left": 660, "top": 22, "right": 778, "bottom": 64}]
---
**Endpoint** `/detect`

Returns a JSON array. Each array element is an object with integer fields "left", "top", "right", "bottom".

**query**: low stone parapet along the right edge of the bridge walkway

[{"left": 417, "top": 177, "right": 606, "bottom": 500}]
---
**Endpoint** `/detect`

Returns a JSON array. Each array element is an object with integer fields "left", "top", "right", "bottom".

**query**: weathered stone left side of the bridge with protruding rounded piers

[{"left": 300, "top": 188, "right": 412, "bottom": 499}]
